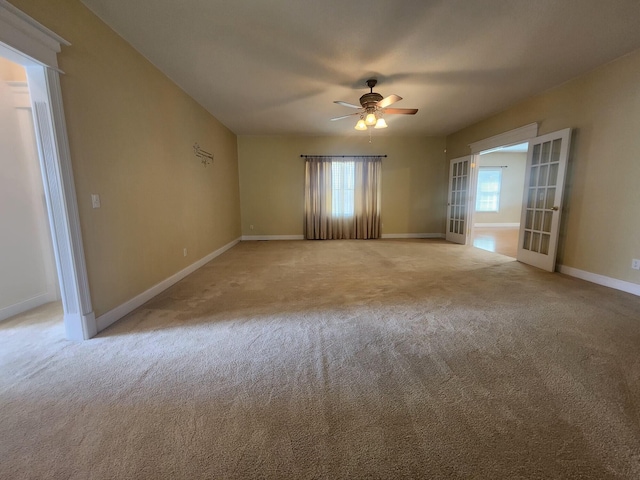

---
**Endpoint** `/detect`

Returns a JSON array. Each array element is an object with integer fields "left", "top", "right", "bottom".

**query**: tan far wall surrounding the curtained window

[{"left": 238, "top": 135, "right": 447, "bottom": 235}]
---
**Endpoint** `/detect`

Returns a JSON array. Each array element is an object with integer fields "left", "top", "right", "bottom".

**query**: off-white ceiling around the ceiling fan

[{"left": 83, "top": 0, "right": 640, "bottom": 135}]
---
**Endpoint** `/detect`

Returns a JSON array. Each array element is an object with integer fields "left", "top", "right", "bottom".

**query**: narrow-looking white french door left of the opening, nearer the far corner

[{"left": 446, "top": 155, "right": 472, "bottom": 245}]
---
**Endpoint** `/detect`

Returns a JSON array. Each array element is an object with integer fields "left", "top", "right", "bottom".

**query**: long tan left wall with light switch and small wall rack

[{"left": 12, "top": 0, "right": 240, "bottom": 315}]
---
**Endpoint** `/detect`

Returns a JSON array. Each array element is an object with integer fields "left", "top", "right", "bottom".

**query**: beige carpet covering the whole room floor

[{"left": 0, "top": 240, "right": 640, "bottom": 480}]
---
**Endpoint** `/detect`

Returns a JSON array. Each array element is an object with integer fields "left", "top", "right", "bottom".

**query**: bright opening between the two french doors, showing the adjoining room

[{"left": 470, "top": 142, "right": 529, "bottom": 258}]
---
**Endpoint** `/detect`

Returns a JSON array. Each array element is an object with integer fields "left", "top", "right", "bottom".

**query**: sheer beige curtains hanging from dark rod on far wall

[{"left": 304, "top": 157, "right": 382, "bottom": 240}]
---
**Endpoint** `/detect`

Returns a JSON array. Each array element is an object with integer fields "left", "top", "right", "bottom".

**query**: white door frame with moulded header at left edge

[{"left": 0, "top": 0, "right": 97, "bottom": 340}]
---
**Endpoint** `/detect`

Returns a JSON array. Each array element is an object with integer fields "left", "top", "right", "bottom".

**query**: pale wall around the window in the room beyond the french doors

[{"left": 473, "top": 152, "right": 527, "bottom": 224}]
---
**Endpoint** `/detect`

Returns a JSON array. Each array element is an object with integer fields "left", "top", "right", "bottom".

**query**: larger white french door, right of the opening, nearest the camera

[{"left": 517, "top": 128, "right": 571, "bottom": 272}]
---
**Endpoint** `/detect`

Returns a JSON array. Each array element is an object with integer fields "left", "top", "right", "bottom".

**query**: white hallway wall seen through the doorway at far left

[{"left": 0, "top": 75, "right": 58, "bottom": 320}]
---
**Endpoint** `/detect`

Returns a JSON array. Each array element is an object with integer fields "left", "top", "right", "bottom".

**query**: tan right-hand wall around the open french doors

[{"left": 447, "top": 50, "right": 640, "bottom": 284}]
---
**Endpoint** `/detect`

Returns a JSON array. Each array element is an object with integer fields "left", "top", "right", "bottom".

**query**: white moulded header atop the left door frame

[{"left": 0, "top": 0, "right": 71, "bottom": 70}]
